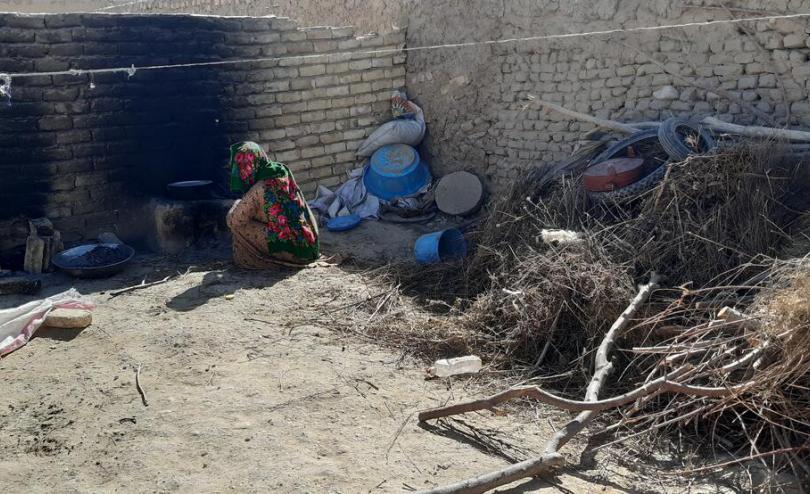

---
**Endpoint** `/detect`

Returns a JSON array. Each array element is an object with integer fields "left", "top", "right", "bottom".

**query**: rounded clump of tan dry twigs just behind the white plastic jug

[{"left": 456, "top": 240, "right": 634, "bottom": 370}]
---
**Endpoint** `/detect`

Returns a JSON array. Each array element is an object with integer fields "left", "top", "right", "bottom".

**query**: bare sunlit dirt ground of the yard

[{"left": 0, "top": 230, "right": 730, "bottom": 493}]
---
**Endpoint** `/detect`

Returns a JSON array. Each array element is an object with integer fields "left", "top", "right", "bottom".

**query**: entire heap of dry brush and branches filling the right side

[{"left": 354, "top": 143, "right": 810, "bottom": 492}]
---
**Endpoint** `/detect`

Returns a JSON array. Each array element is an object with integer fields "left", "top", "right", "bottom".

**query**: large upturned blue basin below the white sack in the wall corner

[{"left": 363, "top": 144, "right": 431, "bottom": 201}]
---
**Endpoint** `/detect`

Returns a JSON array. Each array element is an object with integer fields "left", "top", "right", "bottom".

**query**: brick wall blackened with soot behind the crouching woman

[{"left": 0, "top": 14, "right": 405, "bottom": 250}]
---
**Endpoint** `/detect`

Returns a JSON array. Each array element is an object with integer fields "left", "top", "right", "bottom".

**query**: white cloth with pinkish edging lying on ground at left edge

[{"left": 0, "top": 288, "right": 95, "bottom": 357}]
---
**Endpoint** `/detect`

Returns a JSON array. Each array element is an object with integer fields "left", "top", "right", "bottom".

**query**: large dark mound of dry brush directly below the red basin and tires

[{"left": 607, "top": 143, "right": 810, "bottom": 286}]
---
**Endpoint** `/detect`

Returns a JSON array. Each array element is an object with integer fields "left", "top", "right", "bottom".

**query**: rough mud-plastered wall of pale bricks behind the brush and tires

[{"left": 408, "top": 0, "right": 810, "bottom": 188}]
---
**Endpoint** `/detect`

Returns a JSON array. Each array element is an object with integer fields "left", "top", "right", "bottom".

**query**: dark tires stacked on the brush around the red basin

[{"left": 588, "top": 118, "right": 716, "bottom": 202}]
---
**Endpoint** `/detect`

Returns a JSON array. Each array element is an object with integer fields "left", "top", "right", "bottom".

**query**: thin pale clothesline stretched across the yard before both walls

[{"left": 0, "top": 13, "right": 810, "bottom": 79}]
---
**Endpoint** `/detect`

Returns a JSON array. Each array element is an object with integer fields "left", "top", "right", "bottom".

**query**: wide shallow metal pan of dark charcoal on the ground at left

[{"left": 53, "top": 244, "right": 135, "bottom": 278}]
